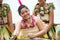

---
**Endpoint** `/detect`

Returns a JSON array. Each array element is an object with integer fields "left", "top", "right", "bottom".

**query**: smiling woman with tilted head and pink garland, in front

[{"left": 11, "top": 5, "right": 50, "bottom": 40}]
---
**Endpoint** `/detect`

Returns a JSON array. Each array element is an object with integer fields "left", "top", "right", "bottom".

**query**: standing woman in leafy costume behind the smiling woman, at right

[{"left": 33, "top": 0, "right": 55, "bottom": 40}]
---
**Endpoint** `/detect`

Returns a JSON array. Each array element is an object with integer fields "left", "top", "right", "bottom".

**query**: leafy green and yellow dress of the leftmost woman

[{"left": 0, "top": 4, "right": 10, "bottom": 40}]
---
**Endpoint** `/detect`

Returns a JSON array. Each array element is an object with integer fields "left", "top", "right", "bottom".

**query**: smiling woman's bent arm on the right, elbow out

[{"left": 35, "top": 18, "right": 47, "bottom": 37}]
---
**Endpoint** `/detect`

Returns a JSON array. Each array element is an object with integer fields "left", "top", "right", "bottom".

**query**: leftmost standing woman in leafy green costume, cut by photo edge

[{"left": 0, "top": 0, "right": 13, "bottom": 40}]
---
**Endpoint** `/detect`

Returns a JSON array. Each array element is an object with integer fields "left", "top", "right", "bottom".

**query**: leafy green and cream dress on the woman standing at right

[{"left": 35, "top": 3, "right": 55, "bottom": 40}]
